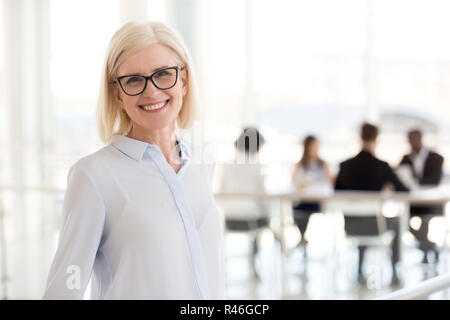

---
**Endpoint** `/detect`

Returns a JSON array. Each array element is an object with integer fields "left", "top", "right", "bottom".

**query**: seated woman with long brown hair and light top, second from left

[{"left": 292, "top": 136, "right": 333, "bottom": 253}]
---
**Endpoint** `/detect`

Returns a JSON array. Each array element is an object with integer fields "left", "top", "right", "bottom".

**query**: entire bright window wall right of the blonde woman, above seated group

[{"left": 197, "top": 0, "right": 450, "bottom": 188}]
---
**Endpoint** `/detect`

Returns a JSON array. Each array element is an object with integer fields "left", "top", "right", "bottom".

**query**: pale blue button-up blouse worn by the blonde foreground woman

[{"left": 44, "top": 135, "right": 224, "bottom": 299}]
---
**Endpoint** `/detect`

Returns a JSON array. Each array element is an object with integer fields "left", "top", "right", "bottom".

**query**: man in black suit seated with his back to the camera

[{"left": 334, "top": 123, "right": 408, "bottom": 285}]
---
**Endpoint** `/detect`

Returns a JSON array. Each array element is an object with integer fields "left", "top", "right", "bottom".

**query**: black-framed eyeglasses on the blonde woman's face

[{"left": 116, "top": 66, "right": 183, "bottom": 96}]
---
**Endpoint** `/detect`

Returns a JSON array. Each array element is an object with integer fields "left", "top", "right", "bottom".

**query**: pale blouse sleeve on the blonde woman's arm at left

[{"left": 43, "top": 164, "right": 105, "bottom": 299}]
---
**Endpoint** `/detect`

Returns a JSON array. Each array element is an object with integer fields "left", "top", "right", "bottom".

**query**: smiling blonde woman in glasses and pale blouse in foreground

[{"left": 44, "top": 22, "right": 223, "bottom": 299}]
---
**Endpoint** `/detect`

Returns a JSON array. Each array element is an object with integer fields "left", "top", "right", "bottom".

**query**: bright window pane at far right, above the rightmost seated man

[{"left": 373, "top": 0, "right": 450, "bottom": 165}]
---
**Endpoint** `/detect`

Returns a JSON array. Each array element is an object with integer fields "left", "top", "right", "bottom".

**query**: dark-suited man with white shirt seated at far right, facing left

[{"left": 400, "top": 129, "right": 444, "bottom": 263}]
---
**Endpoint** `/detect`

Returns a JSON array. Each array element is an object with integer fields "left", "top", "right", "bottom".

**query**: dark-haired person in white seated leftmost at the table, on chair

[{"left": 220, "top": 127, "right": 270, "bottom": 277}]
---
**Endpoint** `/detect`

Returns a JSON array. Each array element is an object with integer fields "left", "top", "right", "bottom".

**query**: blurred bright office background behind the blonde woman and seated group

[{"left": 0, "top": 0, "right": 450, "bottom": 299}]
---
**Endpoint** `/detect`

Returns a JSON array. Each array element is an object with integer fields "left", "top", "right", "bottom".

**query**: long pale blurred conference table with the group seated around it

[{"left": 215, "top": 184, "right": 450, "bottom": 294}]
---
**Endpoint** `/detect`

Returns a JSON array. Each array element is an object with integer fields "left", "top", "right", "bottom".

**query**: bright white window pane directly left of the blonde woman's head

[{"left": 50, "top": 0, "right": 119, "bottom": 185}]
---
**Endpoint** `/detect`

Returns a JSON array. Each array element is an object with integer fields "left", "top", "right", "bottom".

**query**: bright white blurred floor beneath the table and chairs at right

[{"left": 226, "top": 215, "right": 450, "bottom": 300}]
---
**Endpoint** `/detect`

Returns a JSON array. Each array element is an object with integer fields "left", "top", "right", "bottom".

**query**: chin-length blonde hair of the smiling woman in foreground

[{"left": 97, "top": 21, "right": 199, "bottom": 143}]
